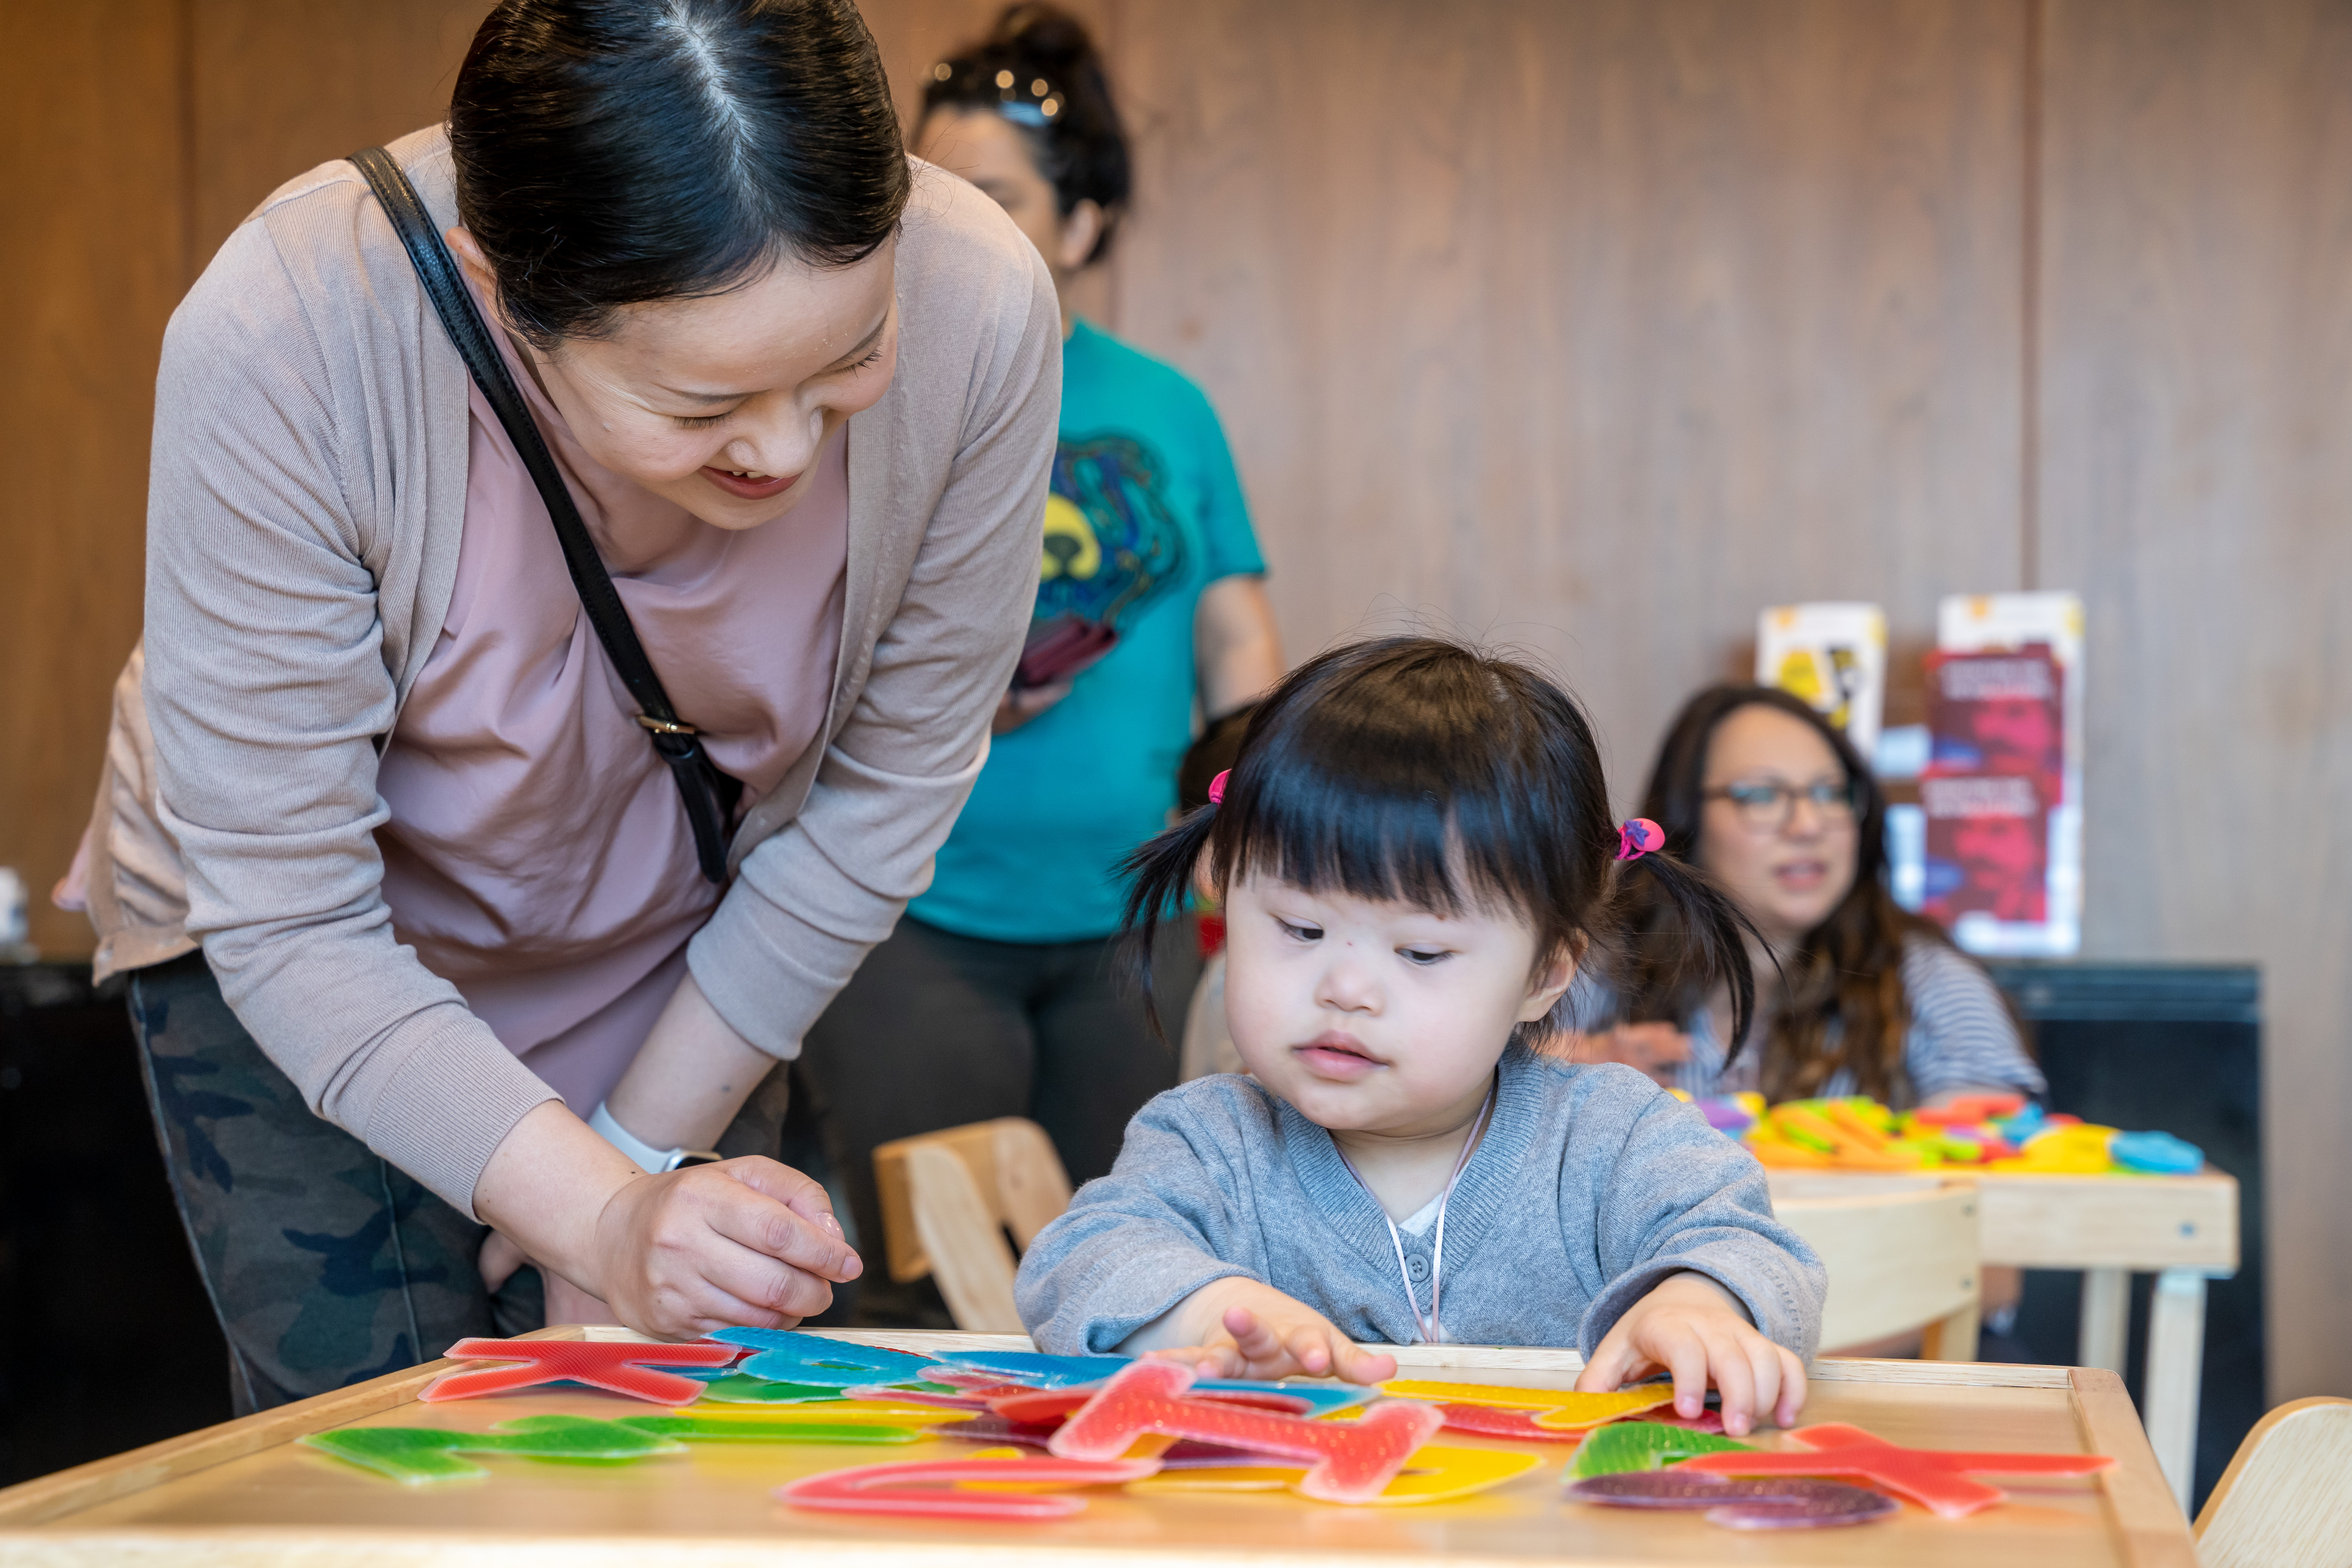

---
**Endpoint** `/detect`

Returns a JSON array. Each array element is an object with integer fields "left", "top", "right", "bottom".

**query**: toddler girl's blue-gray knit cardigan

[{"left": 1016, "top": 1046, "right": 1828, "bottom": 1359}]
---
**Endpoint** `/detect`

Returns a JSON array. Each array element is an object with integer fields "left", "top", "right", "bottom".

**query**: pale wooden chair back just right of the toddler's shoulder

[{"left": 1773, "top": 1185, "right": 1980, "bottom": 1361}]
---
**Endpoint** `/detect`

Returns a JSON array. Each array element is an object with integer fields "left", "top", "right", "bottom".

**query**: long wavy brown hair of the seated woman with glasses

[{"left": 1621, "top": 686, "right": 1945, "bottom": 1103}]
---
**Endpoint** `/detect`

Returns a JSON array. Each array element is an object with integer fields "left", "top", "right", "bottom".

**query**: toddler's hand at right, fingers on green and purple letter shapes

[{"left": 1576, "top": 1274, "right": 1804, "bottom": 1436}]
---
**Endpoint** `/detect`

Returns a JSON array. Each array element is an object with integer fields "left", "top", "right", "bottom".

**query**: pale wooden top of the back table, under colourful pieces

[{"left": 1766, "top": 1166, "right": 2237, "bottom": 1274}]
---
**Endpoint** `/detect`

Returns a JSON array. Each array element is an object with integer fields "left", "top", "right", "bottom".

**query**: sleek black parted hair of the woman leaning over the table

[{"left": 449, "top": 0, "right": 908, "bottom": 348}]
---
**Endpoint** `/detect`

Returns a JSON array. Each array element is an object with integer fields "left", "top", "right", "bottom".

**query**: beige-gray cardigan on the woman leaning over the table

[{"left": 92, "top": 127, "right": 1061, "bottom": 1213}]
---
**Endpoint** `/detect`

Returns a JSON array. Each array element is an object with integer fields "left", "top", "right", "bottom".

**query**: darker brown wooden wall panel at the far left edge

[{"left": 0, "top": 0, "right": 186, "bottom": 952}]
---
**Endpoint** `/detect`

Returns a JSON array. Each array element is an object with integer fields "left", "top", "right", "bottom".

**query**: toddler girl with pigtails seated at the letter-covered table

[{"left": 1018, "top": 637, "right": 1825, "bottom": 1432}]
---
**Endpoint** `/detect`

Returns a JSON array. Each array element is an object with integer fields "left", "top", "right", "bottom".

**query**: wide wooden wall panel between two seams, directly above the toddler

[{"left": 1117, "top": 0, "right": 2025, "bottom": 799}]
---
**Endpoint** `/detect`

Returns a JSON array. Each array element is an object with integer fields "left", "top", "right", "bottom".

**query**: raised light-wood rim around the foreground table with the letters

[{"left": 0, "top": 1326, "right": 2197, "bottom": 1568}]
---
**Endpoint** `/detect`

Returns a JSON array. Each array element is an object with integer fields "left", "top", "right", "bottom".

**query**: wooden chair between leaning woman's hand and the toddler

[{"left": 875, "top": 1117, "right": 1070, "bottom": 1333}]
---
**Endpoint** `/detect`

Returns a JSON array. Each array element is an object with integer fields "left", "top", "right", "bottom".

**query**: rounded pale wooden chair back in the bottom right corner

[{"left": 2197, "top": 1399, "right": 2352, "bottom": 1568}]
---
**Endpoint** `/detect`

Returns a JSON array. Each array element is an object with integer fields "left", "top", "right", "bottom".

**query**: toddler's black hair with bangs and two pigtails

[{"left": 1122, "top": 637, "right": 1755, "bottom": 1044}]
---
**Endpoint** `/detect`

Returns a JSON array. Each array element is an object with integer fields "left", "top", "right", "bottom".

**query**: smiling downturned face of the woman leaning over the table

[{"left": 449, "top": 228, "right": 898, "bottom": 529}]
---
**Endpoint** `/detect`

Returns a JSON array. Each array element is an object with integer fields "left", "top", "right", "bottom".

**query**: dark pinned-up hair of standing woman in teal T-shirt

[{"left": 922, "top": 0, "right": 1134, "bottom": 263}]
